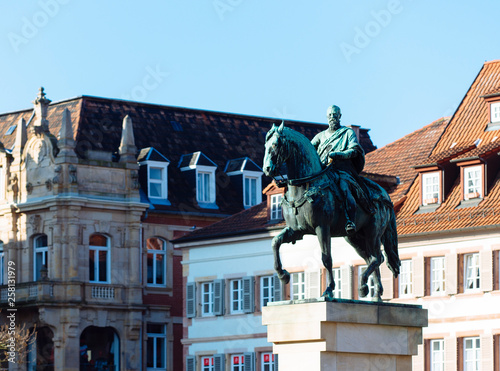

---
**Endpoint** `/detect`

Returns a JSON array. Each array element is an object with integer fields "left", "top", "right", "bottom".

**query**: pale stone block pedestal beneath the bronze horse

[{"left": 262, "top": 299, "right": 427, "bottom": 371}]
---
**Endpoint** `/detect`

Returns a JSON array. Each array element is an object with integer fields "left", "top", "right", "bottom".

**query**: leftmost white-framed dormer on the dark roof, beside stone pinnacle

[{"left": 137, "top": 147, "right": 170, "bottom": 205}]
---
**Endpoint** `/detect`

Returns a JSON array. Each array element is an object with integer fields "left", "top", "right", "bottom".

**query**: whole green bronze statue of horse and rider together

[{"left": 263, "top": 106, "right": 401, "bottom": 301}]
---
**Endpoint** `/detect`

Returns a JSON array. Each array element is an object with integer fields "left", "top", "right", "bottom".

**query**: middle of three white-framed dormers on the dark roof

[{"left": 179, "top": 151, "right": 219, "bottom": 209}]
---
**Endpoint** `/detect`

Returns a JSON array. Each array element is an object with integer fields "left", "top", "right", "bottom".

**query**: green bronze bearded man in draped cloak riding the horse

[{"left": 311, "top": 106, "right": 374, "bottom": 235}]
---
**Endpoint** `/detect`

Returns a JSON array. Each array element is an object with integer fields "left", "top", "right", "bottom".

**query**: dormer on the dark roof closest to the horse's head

[{"left": 224, "top": 157, "right": 263, "bottom": 209}]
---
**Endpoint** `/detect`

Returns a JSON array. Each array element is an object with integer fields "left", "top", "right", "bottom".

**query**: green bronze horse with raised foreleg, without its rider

[{"left": 263, "top": 123, "right": 401, "bottom": 301}]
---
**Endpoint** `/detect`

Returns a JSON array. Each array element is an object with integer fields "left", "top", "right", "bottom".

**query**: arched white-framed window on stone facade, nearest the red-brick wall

[{"left": 89, "top": 234, "right": 111, "bottom": 283}]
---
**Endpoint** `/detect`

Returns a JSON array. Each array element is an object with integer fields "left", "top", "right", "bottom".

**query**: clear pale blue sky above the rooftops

[{"left": 0, "top": 0, "right": 500, "bottom": 147}]
